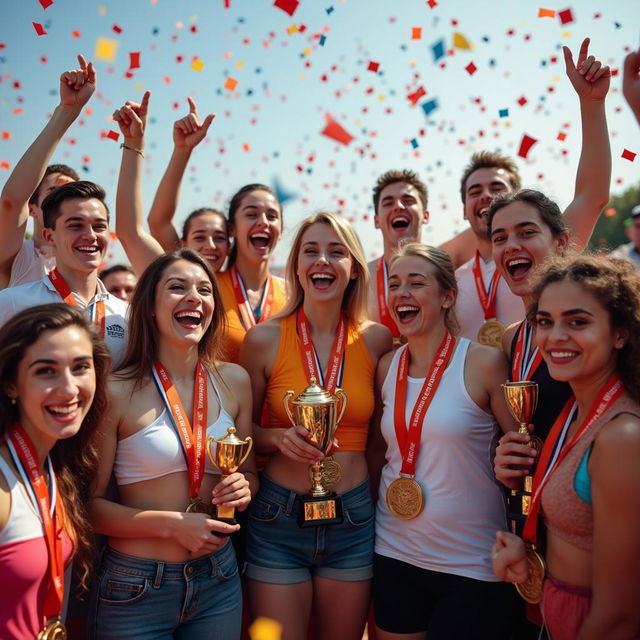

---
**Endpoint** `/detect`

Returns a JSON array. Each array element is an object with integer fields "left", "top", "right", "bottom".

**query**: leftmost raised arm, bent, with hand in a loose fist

[{"left": 0, "top": 55, "right": 96, "bottom": 267}]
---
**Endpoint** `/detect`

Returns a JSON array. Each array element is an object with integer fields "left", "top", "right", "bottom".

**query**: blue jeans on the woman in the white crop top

[{"left": 88, "top": 542, "right": 242, "bottom": 640}]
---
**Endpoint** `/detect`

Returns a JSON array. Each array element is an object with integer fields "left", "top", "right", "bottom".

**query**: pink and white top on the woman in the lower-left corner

[{"left": 0, "top": 456, "right": 73, "bottom": 640}]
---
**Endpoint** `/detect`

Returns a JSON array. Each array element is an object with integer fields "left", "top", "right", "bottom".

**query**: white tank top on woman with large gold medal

[{"left": 375, "top": 338, "right": 507, "bottom": 582}]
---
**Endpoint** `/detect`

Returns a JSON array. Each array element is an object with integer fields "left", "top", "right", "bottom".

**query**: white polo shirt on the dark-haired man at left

[{"left": 0, "top": 276, "right": 129, "bottom": 368}]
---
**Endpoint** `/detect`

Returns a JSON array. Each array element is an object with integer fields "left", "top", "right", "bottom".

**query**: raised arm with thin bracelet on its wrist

[{"left": 113, "top": 91, "right": 164, "bottom": 275}]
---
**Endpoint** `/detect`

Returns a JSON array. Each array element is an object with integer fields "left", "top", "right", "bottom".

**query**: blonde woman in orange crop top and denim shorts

[{"left": 241, "top": 213, "right": 391, "bottom": 640}]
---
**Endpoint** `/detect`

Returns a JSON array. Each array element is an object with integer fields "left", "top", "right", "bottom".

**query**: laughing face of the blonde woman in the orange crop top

[{"left": 296, "top": 222, "right": 356, "bottom": 301}]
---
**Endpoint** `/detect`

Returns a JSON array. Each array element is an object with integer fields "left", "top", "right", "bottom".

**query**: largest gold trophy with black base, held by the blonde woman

[{"left": 282, "top": 377, "right": 347, "bottom": 527}]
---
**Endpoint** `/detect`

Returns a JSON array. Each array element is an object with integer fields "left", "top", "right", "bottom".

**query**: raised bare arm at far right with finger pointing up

[{"left": 563, "top": 38, "right": 611, "bottom": 250}]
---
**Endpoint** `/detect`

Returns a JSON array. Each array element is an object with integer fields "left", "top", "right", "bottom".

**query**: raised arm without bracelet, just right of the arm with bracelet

[{"left": 147, "top": 98, "right": 215, "bottom": 251}]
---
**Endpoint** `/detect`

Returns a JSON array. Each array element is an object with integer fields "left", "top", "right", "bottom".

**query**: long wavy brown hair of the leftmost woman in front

[{"left": 0, "top": 303, "right": 111, "bottom": 588}]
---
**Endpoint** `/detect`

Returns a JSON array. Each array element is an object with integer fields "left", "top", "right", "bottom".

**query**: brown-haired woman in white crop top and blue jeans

[{"left": 90, "top": 249, "right": 257, "bottom": 640}]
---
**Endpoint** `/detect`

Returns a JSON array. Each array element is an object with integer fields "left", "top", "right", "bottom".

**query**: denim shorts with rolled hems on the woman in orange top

[{"left": 245, "top": 475, "right": 375, "bottom": 584}]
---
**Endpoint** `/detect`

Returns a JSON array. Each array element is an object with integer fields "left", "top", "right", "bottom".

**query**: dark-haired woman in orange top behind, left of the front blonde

[{"left": 217, "top": 184, "right": 286, "bottom": 362}]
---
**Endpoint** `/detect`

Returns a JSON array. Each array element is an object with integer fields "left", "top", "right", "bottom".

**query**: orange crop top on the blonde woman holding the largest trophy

[{"left": 265, "top": 313, "right": 375, "bottom": 451}]
